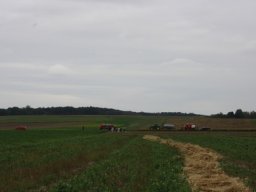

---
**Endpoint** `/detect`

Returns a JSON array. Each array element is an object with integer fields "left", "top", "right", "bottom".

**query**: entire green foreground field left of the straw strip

[{"left": 0, "top": 129, "right": 190, "bottom": 192}]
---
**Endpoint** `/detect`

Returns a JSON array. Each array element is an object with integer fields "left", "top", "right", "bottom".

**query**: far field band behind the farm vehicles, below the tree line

[{"left": 0, "top": 115, "right": 256, "bottom": 130}]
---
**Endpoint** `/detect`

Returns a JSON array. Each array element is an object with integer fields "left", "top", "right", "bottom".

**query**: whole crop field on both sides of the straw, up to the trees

[{"left": 0, "top": 116, "right": 256, "bottom": 192}]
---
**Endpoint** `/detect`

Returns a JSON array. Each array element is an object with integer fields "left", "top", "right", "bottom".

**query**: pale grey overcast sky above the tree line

[{"left": 0, "top": 0, "right": 256, "bottom": 114}]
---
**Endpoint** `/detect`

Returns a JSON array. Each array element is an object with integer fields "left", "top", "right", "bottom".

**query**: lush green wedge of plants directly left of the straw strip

[{"left": 51, "top": 137, "right": 190, "bottom": 192}]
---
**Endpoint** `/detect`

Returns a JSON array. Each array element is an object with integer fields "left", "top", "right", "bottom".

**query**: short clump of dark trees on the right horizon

[{"left": 212, "top": 109, "right": 256, "bottom": 119}]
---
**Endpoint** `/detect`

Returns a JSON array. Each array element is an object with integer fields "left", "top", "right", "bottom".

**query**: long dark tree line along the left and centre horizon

[{"left": 0, "top": 106, "right": 199, "bottom": 116}]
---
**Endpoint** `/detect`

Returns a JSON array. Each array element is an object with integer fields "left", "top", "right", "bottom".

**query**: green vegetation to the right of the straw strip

[{"left": 162, "top": 133, "right": 256, "bottom": 191}]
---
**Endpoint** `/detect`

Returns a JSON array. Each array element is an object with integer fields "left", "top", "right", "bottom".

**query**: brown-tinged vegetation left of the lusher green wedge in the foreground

[{"left": 0, "top": 130, "right": 134, "bottom": 191}]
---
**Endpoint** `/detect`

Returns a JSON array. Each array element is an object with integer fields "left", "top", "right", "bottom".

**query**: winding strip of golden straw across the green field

[{"left": 143, "top": 135, "right": 251, "bottom": 192}]
